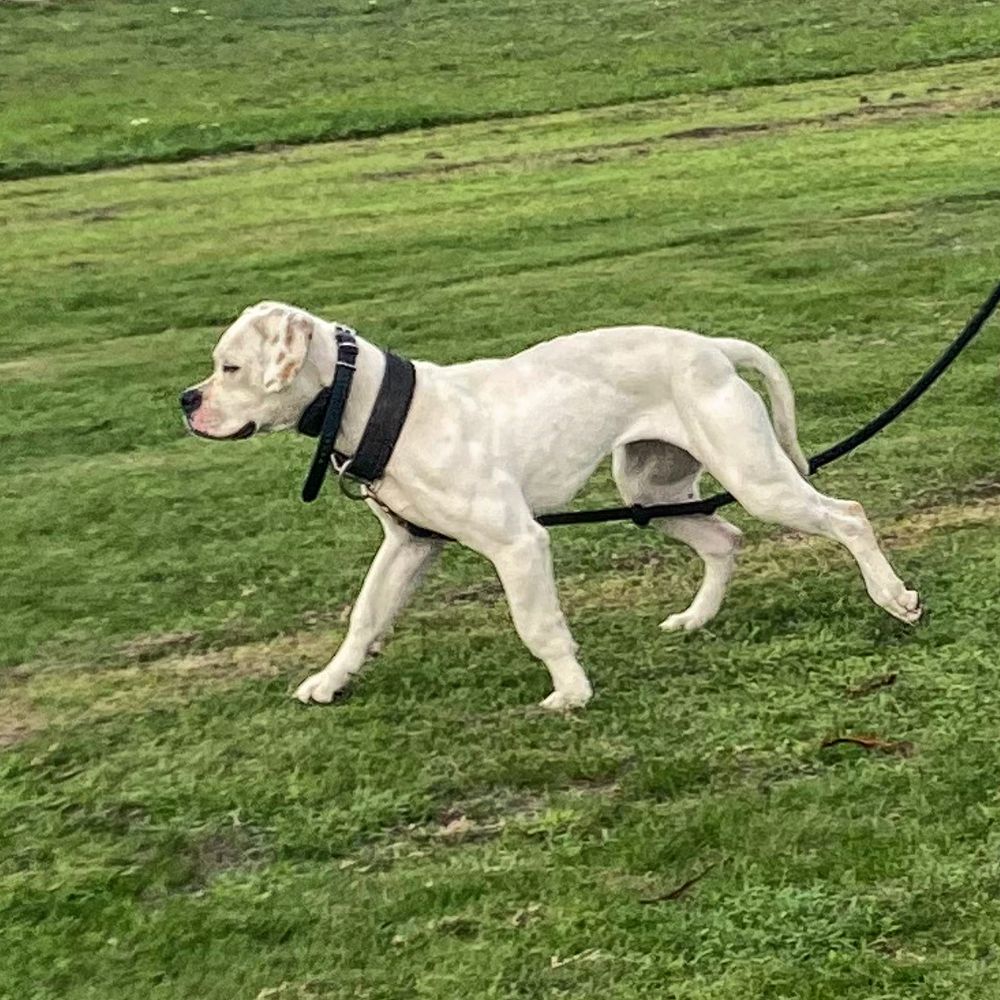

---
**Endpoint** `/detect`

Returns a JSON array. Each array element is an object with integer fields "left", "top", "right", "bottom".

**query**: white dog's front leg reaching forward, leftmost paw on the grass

[{"left": 295, "top": 522, "right": 442, "bottom": 703}]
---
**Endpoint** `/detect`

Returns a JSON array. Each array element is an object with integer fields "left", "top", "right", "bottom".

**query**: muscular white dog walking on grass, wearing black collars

[{"left": 182, "top": 302, "right": 921, "bottom": 709}]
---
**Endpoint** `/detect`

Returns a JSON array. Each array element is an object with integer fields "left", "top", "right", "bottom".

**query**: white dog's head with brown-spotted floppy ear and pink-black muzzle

[{"left": 181, "top": 302, "right": 323, "bottom": 441}]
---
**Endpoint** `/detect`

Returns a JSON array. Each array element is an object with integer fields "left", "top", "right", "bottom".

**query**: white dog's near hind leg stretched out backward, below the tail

[{"left": 679, "top": 355, "right": 921, "bottom": 624}]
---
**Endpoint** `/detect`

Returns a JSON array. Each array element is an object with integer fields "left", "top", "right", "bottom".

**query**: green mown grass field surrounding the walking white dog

[{"left": 0, "top": 0, "right": 1000, "bottom": 1000}]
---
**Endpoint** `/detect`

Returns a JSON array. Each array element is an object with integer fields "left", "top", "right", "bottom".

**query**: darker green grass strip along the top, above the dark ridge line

[{"left": 0, "top": 0, "right": 1000, "bottom": 178}]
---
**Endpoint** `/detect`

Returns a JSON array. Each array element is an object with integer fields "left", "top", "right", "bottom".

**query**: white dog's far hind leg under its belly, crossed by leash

[{"left": 611, "top": 441, "right": 743, "bottom": 631}]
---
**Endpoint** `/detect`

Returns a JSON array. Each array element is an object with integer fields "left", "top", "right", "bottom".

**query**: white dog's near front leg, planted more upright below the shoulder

[{"left": 474, "top": 521, "right": 593, "bottom": 711}]
